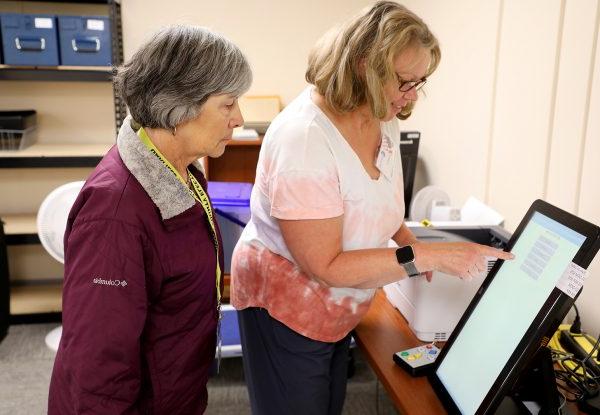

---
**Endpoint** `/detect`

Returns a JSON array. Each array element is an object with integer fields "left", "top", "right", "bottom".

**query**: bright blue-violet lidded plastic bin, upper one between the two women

[{"left": 208, "top": 182, "right": 252, "bottom": 274}]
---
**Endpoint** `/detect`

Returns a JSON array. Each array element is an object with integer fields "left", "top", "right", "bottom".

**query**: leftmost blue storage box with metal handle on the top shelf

[{"left": 0, "top": 13, "right": 58, "bottom": 66}]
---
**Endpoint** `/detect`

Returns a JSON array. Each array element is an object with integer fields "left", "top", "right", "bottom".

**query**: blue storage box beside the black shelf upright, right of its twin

[{"left": 58, "top": 16, "right": 112, "bottom": 66}]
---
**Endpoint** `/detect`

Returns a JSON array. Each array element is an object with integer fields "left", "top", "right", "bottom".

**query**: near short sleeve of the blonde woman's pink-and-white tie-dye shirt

[{"left": 265, "top": 118, "right": 344, "bottom": 220}]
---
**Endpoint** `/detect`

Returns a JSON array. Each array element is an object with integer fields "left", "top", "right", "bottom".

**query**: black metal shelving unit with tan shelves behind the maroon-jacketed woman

[{"left": 0, "top": 0, "right": 116, "bottom": 324}]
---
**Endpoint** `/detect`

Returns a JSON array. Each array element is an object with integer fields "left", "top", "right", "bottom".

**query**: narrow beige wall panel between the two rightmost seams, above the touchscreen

[{"left": 545, "top": 0, "right": 598, "bottom": 212}]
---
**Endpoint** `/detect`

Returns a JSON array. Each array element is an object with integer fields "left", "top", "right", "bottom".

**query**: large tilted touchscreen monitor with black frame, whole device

[{"left": 429, "top": 200, "right": 599, "bottom": 414}]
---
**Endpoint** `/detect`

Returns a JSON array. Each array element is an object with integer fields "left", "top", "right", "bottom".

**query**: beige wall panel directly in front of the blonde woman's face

[{"left": 394, "top": 0, "right": 500, "bottom": 206}]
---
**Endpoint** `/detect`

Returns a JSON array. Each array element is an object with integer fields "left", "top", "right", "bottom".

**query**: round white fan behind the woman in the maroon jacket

[{"left": 37, "top": 181, "right": 85, "bottom": 351}]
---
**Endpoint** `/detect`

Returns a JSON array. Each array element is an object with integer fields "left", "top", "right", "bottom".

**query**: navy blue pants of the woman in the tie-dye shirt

[{"left": 238, "top": 308, "right": 350, "bottom": 415}]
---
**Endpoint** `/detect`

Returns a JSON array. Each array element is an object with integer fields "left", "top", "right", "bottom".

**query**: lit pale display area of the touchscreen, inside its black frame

[{"left": 436, "top": 212, "right": 585, "bottom": 414}]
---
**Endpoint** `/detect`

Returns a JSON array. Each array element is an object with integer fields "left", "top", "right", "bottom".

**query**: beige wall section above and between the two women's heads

[{"left": 122, "top": 0, "right": 372, "bottom": 104}]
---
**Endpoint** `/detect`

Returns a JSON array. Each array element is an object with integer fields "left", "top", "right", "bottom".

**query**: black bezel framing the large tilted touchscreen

[{"left": 429, "top": 199, "right": 600, "bottom": 414}]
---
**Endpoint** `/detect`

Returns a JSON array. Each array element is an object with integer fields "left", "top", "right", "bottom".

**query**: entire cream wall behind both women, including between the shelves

[{"left": 0, "top": 0, "right": 600, "bottom": 331}]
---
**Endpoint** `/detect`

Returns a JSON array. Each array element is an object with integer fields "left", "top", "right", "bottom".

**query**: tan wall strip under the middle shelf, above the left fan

[{"left": 0, "top": 168, "right": 92, "bottom": 215}]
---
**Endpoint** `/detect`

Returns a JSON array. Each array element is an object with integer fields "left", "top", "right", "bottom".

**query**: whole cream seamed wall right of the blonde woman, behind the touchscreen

[{"left": 406, "top": 0, "right": 600, "bottom": 333}]
